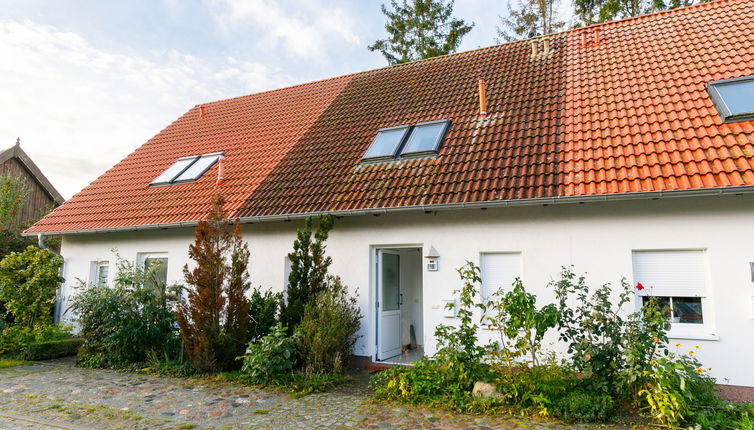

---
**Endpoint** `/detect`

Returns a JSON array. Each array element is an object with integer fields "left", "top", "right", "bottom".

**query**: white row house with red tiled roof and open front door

[{"left": 27, "top": 0, "right": 754, "bottom": 386}]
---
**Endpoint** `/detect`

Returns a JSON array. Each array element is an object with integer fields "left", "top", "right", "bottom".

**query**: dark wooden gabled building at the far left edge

[{"left": 0, "top": 139, "right": 65, "bottom": 232}]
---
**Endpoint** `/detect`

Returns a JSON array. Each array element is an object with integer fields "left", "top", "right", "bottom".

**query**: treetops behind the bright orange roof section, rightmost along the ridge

[{"left": 574, "top": 0, "right": 709, "bottom": 25}]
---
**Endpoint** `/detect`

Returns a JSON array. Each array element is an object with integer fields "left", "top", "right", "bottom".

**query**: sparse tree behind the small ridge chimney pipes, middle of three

[{"left": 497, "top": 0, "right": 565, "bottom": 42}]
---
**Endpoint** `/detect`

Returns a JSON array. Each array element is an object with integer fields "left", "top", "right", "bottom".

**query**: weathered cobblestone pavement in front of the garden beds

[{"left": 0, "top": 360, "right": 624, "bottom": 430}]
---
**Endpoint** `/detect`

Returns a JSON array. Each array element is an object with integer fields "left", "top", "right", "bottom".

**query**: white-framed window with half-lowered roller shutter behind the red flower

[{"left": 633, "top": 250, "right": 709, "bottom": 328}]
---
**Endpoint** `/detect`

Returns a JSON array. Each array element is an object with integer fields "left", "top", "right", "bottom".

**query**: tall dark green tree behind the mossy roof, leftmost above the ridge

[{"left": 368, "top": 0, "right": 474, "bottom": 64}]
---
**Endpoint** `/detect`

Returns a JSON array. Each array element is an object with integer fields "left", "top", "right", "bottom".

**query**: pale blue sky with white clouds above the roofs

[{"left": 0, "top": 0, "right": 568, "bottom": 198}]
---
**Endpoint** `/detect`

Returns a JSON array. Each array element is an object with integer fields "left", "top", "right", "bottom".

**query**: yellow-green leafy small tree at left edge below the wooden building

[{"left": 0, "top": 246, "right": 64, "bottom": 328}]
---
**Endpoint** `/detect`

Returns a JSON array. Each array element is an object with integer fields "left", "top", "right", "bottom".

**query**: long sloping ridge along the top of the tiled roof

[{"left": 194, "top": 0, "right": 740, "bottom": 107}]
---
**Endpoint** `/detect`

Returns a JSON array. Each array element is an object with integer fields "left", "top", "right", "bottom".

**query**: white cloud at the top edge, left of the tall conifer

[{"left": 209, "top": 0, "right": 361, "bottom": 60}]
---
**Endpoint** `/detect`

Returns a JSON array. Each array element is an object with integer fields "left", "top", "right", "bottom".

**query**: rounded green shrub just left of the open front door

[{"left": 295, "top": 277, "right": 361, "bottom": 373}]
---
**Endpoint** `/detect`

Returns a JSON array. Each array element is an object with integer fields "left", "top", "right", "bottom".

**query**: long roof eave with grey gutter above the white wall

[{"left": 22, "top": 185, "right": 754, "bottom": 236}]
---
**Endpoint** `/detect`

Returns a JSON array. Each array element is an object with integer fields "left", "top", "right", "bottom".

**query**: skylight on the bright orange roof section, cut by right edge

[{"left": 707, "top": 76, "right": 754, "bottom": 122}]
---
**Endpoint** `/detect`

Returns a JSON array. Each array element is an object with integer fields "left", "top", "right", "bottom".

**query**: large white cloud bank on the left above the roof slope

[{"left": 0, "top": 21, "right": 295, "bottom": 197}]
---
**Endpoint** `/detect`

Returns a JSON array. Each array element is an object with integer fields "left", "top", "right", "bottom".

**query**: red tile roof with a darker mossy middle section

[{"left": 28, "top": 0, "right": 754, "bottom": 233}]
